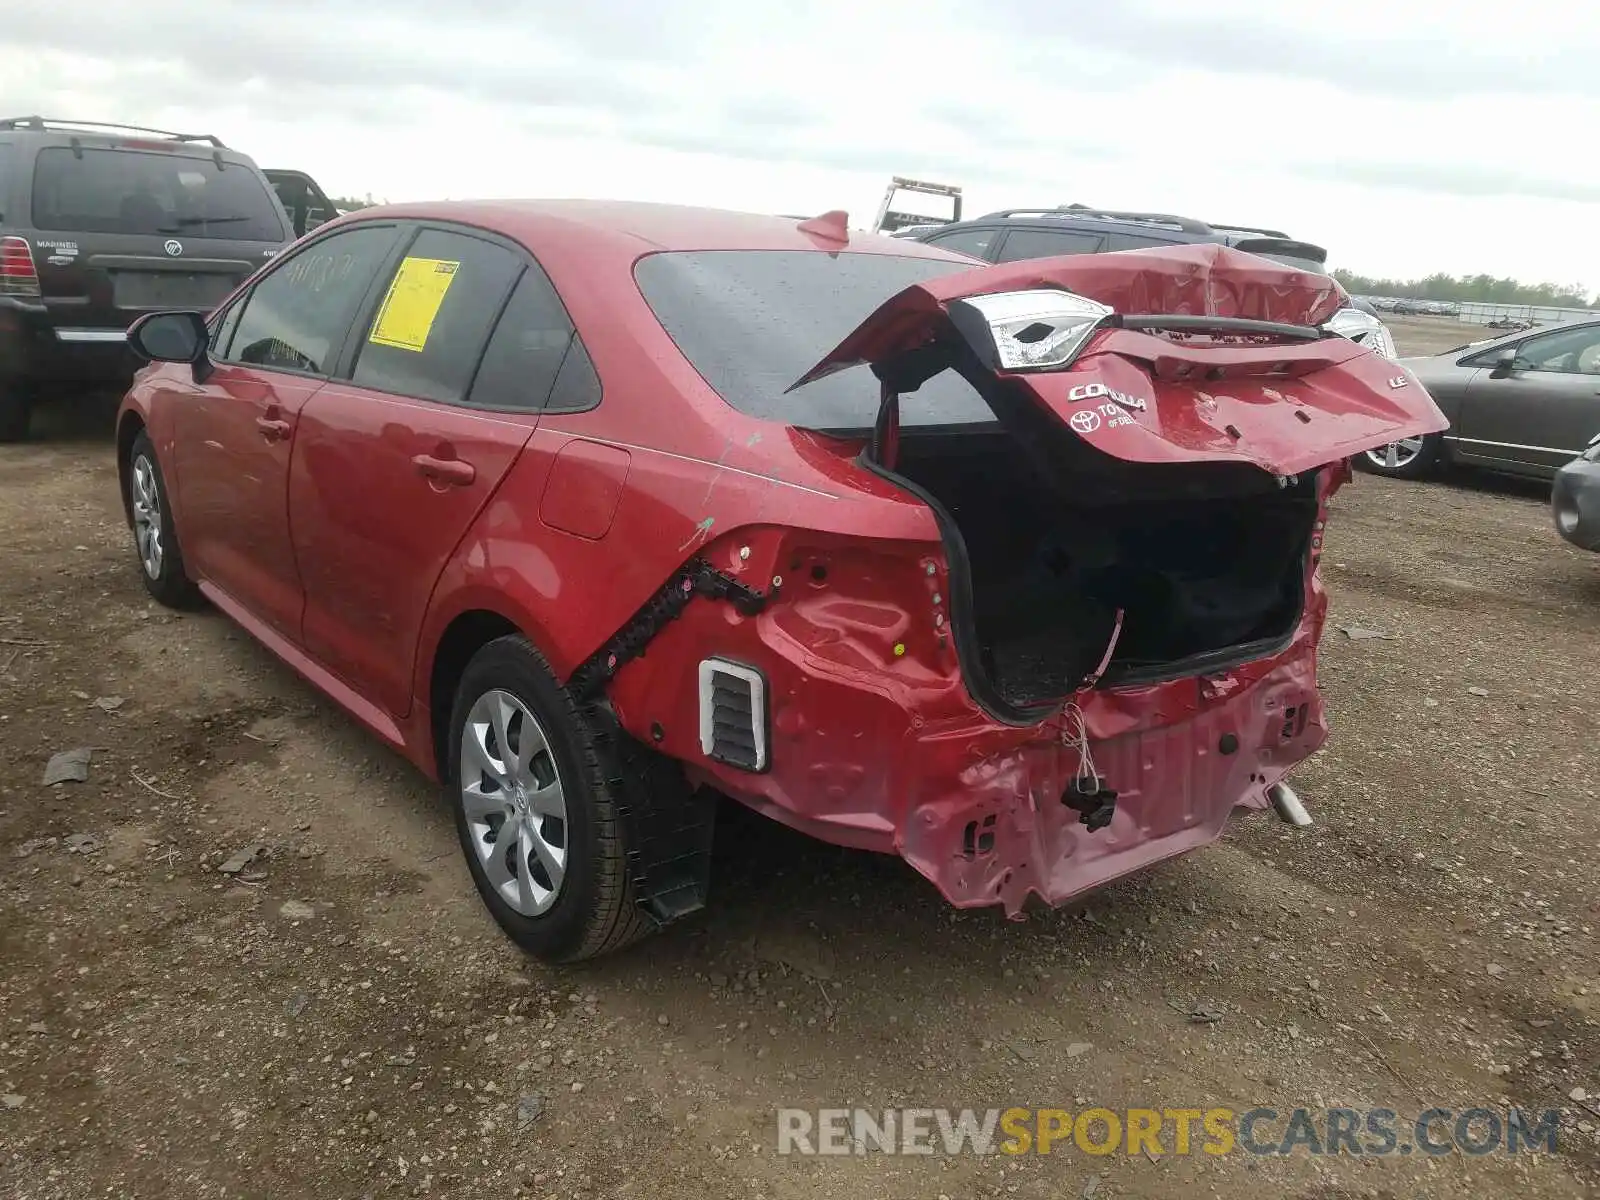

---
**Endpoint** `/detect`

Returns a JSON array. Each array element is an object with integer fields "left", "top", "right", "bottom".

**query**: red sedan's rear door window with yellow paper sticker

[{"left": 352, "top": 229, "right": 523, "bottom": 403}]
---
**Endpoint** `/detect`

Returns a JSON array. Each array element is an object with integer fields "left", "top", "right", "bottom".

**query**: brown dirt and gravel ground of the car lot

[{"left": 0, "top": 322, "right": 1600, "bottom": 1200}]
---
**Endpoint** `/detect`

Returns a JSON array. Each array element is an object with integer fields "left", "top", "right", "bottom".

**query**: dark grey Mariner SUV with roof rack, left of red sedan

[{"left": 0, "top": 117, "right": 336, "bottom": 442}]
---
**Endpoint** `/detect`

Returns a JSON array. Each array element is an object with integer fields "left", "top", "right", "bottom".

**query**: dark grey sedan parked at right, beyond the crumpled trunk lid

[{"left": 1358, "top": 320, "right": 1600, "bottom": 478}]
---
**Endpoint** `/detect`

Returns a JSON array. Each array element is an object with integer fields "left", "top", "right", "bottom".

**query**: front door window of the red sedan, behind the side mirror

[{"left": 218, "top": 226, "right": 395, "bottom": 374}]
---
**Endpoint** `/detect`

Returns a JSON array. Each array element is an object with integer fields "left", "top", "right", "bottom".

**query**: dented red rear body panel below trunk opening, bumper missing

[{"left": 602, "top": 512, "right": 1326, "bottom": 914}]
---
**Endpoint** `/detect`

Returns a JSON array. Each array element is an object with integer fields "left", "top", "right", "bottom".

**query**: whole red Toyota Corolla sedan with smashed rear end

[{"left": 117, "top": 202, "right": 1445, "bottom": 960}]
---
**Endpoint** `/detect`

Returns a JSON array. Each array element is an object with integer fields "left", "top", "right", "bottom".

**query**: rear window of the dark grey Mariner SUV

[{"left": 34, "top": 147, "right": 288, "bottom": 242}]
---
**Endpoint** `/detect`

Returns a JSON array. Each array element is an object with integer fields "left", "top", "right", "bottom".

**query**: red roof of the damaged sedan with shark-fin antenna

[{"left": 339, "top": 200, "right": 966, "bottom": 261}]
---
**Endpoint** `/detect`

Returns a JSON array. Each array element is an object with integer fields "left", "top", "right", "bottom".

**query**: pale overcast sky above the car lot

[{"left": 0, "top": 0, "right": 1600, "bottom": 291}]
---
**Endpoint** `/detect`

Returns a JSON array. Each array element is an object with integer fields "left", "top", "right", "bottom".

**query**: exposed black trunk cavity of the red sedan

[{"left": 888, "top": 427, "right": 1318, "bottom": 717}]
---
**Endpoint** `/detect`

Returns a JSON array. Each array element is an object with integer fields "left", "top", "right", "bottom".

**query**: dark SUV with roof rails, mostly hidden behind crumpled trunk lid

[{"left": 909, "top": 205, "right": 1373, "bottom": 314}]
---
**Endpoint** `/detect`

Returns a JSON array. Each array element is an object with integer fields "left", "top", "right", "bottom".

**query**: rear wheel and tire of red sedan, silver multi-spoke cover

[{"left": 446, "top": 635, "right": 654, "bottom": 963}]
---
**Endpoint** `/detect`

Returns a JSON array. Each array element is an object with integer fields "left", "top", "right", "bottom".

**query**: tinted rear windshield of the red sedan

[{"left": 634, "top": 250, "right": 994, "bottom": 430}]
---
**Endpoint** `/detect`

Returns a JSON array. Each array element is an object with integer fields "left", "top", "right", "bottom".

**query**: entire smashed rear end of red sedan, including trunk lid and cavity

[{"left": 608, "top": 245, "right": 1443, "bottom": 915}]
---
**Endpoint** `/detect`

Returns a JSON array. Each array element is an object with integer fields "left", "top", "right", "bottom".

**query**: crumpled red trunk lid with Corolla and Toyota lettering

[{"left": 795, "top": 245, "right": 1448, "bottom": 475}]
